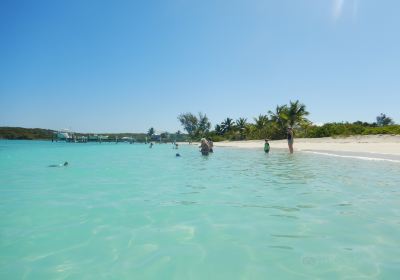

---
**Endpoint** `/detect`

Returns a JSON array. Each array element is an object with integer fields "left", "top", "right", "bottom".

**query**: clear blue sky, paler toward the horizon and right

[{"left": 0, "top": 0, "right": 400, "bottom": 132}]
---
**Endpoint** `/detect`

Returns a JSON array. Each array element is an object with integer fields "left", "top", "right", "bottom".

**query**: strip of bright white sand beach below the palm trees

[{"left": 214, "top": 135, "right": 400, "bottom": 157}]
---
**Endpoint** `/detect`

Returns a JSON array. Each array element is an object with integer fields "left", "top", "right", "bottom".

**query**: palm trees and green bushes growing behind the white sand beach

[{"left": 178, "top": 100, "right": 400, "bottom": 141}]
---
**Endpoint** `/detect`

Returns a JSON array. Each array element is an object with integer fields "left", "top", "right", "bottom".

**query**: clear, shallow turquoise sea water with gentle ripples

[{"left": 0, "top": 141, "right": 400, "bottom": 279}]
